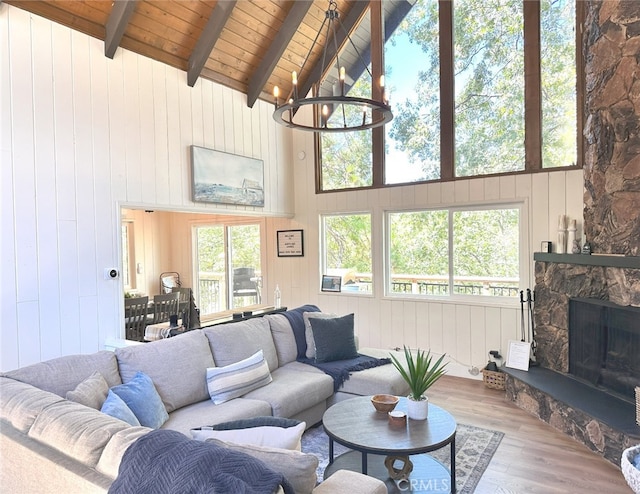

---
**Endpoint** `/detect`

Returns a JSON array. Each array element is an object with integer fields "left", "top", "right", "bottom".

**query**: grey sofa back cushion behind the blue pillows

[{"left": 116, "top": 330, "right": 215, "bottom": 413}]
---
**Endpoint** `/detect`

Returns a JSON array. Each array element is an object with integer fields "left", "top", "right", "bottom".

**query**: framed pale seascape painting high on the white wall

[{"left": 191, "top": 146, "right": 264, "bottom": 207}]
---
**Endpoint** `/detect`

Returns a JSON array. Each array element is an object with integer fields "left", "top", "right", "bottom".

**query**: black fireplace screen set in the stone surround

[{"left": 569, "top": 299, "right": 640, "bottom": 400}]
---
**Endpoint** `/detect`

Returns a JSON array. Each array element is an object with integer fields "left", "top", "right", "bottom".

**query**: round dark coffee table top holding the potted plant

[{"left": 322, "top": 396, "right": 457, "bottom": 455}]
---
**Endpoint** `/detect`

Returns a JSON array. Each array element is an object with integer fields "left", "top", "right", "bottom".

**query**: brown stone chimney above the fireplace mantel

[{"left": 583, "top": 0, "right": 640, "bottom": 256}]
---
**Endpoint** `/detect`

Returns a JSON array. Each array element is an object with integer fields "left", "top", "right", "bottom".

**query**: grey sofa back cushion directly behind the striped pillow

[{"left": 202, "top": 317, "right": 278, "bottom": 372}]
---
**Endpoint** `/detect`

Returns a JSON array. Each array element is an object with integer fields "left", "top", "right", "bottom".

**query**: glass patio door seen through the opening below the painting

[{"left": 194, "top": 224, "right": 262, "bottom": 316}]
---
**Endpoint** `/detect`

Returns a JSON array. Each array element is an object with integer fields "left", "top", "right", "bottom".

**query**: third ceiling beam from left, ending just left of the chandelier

[{"left": 247, "top": 0, "right": 313, "bottom": 108}]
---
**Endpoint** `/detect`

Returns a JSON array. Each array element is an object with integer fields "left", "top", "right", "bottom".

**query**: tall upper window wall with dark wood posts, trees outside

[{"left": 317, "top": 0, "right": 582, "bottom": 191}]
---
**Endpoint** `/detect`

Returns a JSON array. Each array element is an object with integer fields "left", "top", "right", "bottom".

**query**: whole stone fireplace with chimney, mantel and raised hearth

[{"left": 505, "top": 0, "right": 640, "bottom": 465}]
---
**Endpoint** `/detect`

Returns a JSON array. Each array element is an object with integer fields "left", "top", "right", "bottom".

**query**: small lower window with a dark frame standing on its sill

[{"left": 320, "top": 213, "right": 373, "bottom": 293}]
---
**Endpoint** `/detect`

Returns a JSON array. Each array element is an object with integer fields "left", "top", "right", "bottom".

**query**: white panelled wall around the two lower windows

[{"left": 272, "top": 132, "right": 583, "bottom": 377}]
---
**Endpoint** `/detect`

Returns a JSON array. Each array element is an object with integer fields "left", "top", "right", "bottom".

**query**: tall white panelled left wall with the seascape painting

[{"left": 0, "top": 3, "right": 294, "bottom": 370}]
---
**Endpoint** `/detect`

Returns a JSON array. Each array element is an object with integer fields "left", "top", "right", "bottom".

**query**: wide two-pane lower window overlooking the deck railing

[{"left": 387, "top": 204, "right": 520, "bottom": 297}]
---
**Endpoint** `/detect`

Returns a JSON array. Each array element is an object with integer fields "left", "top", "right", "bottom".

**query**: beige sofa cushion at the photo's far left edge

[{"left": 0, "top": 377, "right": 64, "bottom": 434}]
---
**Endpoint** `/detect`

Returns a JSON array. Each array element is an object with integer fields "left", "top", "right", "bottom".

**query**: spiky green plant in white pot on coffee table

[{"left": 391, "top": 346, "right": 448, "bottom": 420}]
